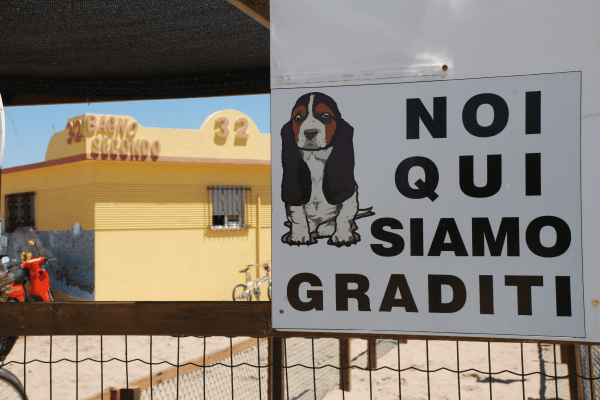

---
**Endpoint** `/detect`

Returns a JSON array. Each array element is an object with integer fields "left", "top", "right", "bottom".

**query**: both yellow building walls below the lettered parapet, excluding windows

[{"left": 2, "top": 161, "right": 271, "bottom": 301}]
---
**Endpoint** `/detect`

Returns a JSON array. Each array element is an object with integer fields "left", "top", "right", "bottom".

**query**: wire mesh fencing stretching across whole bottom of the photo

[{"left": 3, "top": 336, "right": 600, "bottom": 400}]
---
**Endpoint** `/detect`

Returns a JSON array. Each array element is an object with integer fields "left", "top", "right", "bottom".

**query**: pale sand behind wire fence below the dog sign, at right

[{"left": 325, "top": 340, "right": 569, "bottom": 400}]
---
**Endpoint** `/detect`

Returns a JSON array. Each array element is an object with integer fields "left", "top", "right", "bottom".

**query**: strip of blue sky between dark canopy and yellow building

[{"left": 2, "top": 94, "right": 271, "bottom": 168}]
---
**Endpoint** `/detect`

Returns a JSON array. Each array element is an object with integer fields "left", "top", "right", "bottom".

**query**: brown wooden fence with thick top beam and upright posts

[{"left": 0, "top": 302, "right": 589, "bottom": 399}]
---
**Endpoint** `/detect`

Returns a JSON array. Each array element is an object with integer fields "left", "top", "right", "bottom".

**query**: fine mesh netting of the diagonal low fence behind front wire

[{"left": 142, "top": 338, "right": 397, "bottom": 400}]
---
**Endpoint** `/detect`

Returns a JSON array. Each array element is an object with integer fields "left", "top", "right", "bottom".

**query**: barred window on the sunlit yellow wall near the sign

[{"left": 208, "top": 186, "right": 250, "bottom": 229}]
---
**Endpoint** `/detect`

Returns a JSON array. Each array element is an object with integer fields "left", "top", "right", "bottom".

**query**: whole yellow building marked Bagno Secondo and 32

[{"left": 2, "top": 110, "right": 271, "bottom": 301}]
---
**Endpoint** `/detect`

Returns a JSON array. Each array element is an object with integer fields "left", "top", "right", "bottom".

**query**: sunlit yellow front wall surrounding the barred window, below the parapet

[{"left": 94, "top": 163, "right": 271, "bottom": 301}]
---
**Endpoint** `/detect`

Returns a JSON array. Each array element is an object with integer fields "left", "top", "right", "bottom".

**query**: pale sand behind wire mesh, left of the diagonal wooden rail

[{"left": 5, "top": 336, "right": 248, "bottom": 400}]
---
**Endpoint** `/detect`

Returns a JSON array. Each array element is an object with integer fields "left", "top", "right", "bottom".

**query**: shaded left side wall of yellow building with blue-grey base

[{"left": 0, "top": 161, "right": 95, "bottom": 300}]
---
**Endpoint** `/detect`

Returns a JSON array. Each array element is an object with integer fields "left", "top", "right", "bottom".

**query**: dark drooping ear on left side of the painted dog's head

[{"left": 281, "top": 121, "right": 311, "bottom": 206}]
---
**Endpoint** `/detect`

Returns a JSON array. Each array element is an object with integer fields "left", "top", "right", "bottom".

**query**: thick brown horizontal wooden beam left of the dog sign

[{"left": 0, "top": 302, "right": 271, "bottom": 337}]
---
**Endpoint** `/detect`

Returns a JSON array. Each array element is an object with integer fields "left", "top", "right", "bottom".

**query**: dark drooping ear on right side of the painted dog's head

[{"left": 324, "top": 119, "right": 356, "bottom": 204}]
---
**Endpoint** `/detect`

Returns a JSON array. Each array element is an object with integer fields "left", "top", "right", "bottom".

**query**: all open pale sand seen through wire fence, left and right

[{"left": 1, "top": 336, "right": 569, "bottom": 400}]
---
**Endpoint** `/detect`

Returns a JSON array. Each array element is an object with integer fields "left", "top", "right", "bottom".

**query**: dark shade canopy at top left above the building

[{"left": 0, "top": 0, "right": 269, "bottom": 106}]
